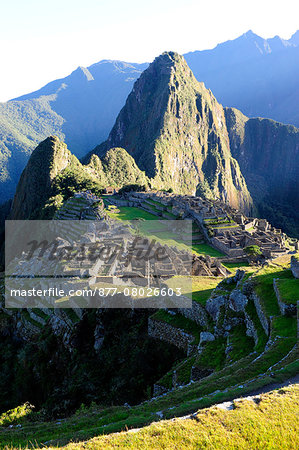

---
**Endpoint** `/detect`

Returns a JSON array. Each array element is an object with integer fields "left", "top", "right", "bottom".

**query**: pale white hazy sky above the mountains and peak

[{"left": 0, "top": 0, "right": 299, "bottom": 101}]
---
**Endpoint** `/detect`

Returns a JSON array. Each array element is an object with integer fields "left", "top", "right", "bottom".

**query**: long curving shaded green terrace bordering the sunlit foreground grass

[{"left": 0, "top": 355, "right": 299, "bottom": 448}]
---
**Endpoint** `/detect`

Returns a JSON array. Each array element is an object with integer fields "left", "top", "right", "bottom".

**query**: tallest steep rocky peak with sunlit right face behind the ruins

[{"left": 94, "top": 52, "right": 252, "bottom": 211}]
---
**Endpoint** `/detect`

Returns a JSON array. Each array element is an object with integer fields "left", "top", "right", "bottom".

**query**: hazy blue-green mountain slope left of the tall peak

[{"left": 0, "top": 61, "right": 147, "bottom": 203}]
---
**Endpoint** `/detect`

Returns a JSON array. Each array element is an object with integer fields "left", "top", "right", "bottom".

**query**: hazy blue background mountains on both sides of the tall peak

[{"left": 0, "top": 31, "right": 299, "bottom": 207}]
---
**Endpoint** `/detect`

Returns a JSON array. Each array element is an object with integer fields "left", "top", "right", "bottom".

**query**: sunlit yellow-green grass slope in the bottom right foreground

[{"left": 66, "top": 385, "right": 299, "bottom": 450}]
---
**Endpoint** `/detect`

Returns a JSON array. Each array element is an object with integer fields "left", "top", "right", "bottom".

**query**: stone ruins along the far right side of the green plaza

[{"left": 108, "top": 191, "right": 298, "bottom": 259}]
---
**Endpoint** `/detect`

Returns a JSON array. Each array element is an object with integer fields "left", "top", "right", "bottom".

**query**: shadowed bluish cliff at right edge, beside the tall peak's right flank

[{"left": 225, "top": 108, "right": 299, "bottom": 232}]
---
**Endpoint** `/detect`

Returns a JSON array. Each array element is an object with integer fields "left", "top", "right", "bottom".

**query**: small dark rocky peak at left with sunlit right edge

[{"left": 9, "top": 136, "right": 74, "bottom": 220}]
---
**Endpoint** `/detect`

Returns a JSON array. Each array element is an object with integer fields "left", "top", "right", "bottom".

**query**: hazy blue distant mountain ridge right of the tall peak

[{"left": 184, "top": 30, "right": 299, "bottom": 127}]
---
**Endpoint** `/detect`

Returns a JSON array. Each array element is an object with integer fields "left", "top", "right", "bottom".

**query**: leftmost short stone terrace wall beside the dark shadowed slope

[{"left": 148, "top": 318, "right": 194, "bottom": 353}]
